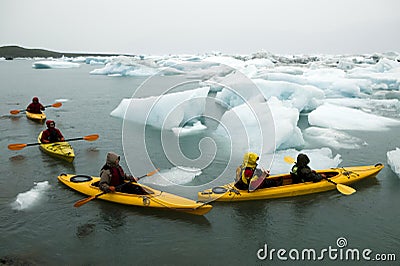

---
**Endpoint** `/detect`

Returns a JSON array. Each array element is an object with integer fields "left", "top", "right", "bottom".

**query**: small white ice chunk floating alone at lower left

[{"left": 11, "top": 181, "right": 50, "bottom": 210}]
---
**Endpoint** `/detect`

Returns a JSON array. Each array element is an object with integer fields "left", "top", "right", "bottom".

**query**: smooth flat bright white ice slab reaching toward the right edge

[{"left": 308, "top": 103, "right": 400, "bottom": 131}]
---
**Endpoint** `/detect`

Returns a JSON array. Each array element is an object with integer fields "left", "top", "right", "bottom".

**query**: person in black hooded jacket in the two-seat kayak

[{"left": 290, "top": 153, "right": 323, "bottom": 184}]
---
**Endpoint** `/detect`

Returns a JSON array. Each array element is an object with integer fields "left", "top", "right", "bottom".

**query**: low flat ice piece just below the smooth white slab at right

[{"left": 303, "top": 127, "right": 367, "bottom": 149}]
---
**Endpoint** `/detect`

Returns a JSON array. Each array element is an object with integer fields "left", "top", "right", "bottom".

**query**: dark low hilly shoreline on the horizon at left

[{"left": 0, "top": 45, "right": 131, "bottom": 60}]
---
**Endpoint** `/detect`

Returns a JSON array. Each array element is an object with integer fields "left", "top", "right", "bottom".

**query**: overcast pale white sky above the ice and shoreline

[{"left": 0, "top": 0, "right": 400, "bottom": 55}]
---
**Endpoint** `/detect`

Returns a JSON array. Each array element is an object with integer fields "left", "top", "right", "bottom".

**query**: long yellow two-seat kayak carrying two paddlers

[{"left": 198, "top": 163, "right": 384, "bottom": 202}]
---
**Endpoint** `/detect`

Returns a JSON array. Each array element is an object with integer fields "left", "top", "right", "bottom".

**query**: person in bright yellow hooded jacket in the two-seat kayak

[{"left": 235, "top": 152, "right": 282, "bottom": 190}]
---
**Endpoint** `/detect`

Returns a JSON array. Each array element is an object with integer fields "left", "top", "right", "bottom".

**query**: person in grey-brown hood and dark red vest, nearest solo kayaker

[{"left": 99, "top": 152, "right": 148, "bottom": 195}]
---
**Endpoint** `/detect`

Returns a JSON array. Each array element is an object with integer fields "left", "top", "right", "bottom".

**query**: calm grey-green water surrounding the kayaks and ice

[{"left": 0, "top": 60, "right": 400, "bottom": 265}]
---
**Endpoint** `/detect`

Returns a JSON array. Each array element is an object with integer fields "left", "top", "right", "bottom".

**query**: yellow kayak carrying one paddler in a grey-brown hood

[{"left": 58, "top": 174, "right": 212, "bottom": 215}]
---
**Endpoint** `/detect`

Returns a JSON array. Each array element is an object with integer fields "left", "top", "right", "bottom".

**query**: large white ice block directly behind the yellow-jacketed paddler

[{"left": 216, "top": 97, "right": 304, "bottom": 152}]
